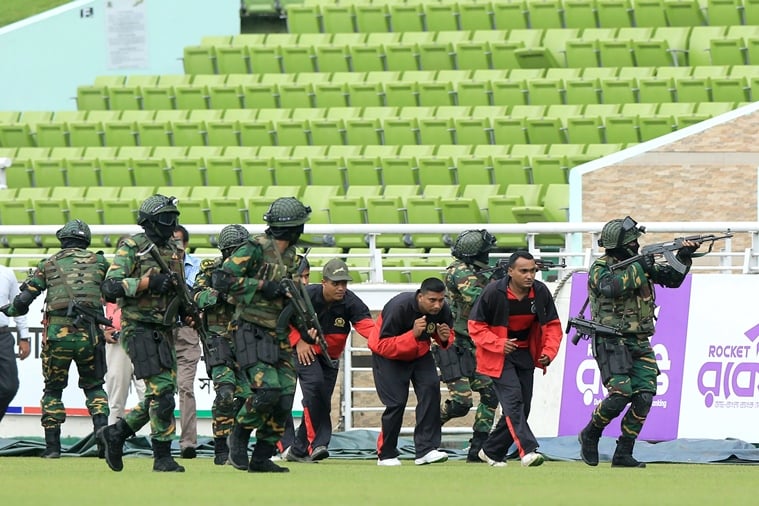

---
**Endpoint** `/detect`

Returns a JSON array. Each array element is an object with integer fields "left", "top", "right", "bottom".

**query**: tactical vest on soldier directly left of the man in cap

[{"left": 238, "top": 235, "right": 296, "bottom": 330}]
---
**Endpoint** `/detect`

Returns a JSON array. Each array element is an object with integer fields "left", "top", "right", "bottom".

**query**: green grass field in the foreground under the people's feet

[{"left": 0, "top": 457, "right": 758, "bottom": 506}]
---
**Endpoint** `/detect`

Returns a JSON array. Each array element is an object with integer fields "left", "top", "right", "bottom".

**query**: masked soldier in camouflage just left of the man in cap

[{"left": 212, "top": 197, "right": 311, "bottom": 473}]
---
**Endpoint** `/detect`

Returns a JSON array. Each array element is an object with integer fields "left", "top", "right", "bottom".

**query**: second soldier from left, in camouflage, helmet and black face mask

[{"left": 97, "top": 195, "right": 185, "bottom": 472}]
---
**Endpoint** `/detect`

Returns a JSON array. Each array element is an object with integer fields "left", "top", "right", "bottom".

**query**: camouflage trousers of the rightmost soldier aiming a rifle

[{"left": 592, "top": 335, "right": 659, "bottom": 438}]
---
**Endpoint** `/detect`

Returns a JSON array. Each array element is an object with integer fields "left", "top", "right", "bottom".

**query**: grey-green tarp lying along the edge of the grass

[{"left": 0, "top": 430, "right": 759, "bottom": 464}]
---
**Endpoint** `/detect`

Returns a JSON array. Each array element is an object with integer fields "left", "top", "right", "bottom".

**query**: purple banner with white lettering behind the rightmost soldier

[{"left": 558, "top": 273, "right": 691, "bottom": 441}]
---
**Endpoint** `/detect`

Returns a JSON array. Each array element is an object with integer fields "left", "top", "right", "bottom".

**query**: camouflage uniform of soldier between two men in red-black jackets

[{"left": 440, "top": 260, "right": 498, "bottom": 436}]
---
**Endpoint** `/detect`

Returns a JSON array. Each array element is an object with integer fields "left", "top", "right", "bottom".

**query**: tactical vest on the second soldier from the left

[{"left": 122, "top": 233, "right": 185, "bottom": 325}]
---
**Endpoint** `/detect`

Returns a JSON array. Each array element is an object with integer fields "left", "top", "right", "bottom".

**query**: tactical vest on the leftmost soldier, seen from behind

[{"left": 44, "top": 248, "right": 105, "bottom": 311}]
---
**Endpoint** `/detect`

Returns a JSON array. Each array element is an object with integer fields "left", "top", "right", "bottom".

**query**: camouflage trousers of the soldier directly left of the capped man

[{"left": 235, "top": 339, "right": 296, "bottom": 446}]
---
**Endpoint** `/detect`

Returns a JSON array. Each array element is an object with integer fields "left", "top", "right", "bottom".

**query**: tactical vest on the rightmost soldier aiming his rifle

[{"left": 590, "top": 257, "right": 656, "bottom": 335}]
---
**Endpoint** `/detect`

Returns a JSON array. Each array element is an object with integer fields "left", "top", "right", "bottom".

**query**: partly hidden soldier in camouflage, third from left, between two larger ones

[{"left": 193, "top": 225, "right": 249, "bottom": 465}]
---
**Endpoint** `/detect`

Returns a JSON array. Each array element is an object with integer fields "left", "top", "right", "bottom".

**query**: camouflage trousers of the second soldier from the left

[{"left": 121, "top": 325, "right": 177, "bottom": 441}]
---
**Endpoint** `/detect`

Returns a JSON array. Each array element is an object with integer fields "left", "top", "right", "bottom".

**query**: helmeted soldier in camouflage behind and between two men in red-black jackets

[{"left": 440, "top": 230, "right": 498, "bottom": 462}]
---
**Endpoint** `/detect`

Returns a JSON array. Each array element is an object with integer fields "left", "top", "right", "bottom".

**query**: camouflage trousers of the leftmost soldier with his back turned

[{"left": 40, "top": 324, "right": 110, "bottom": 429}]
